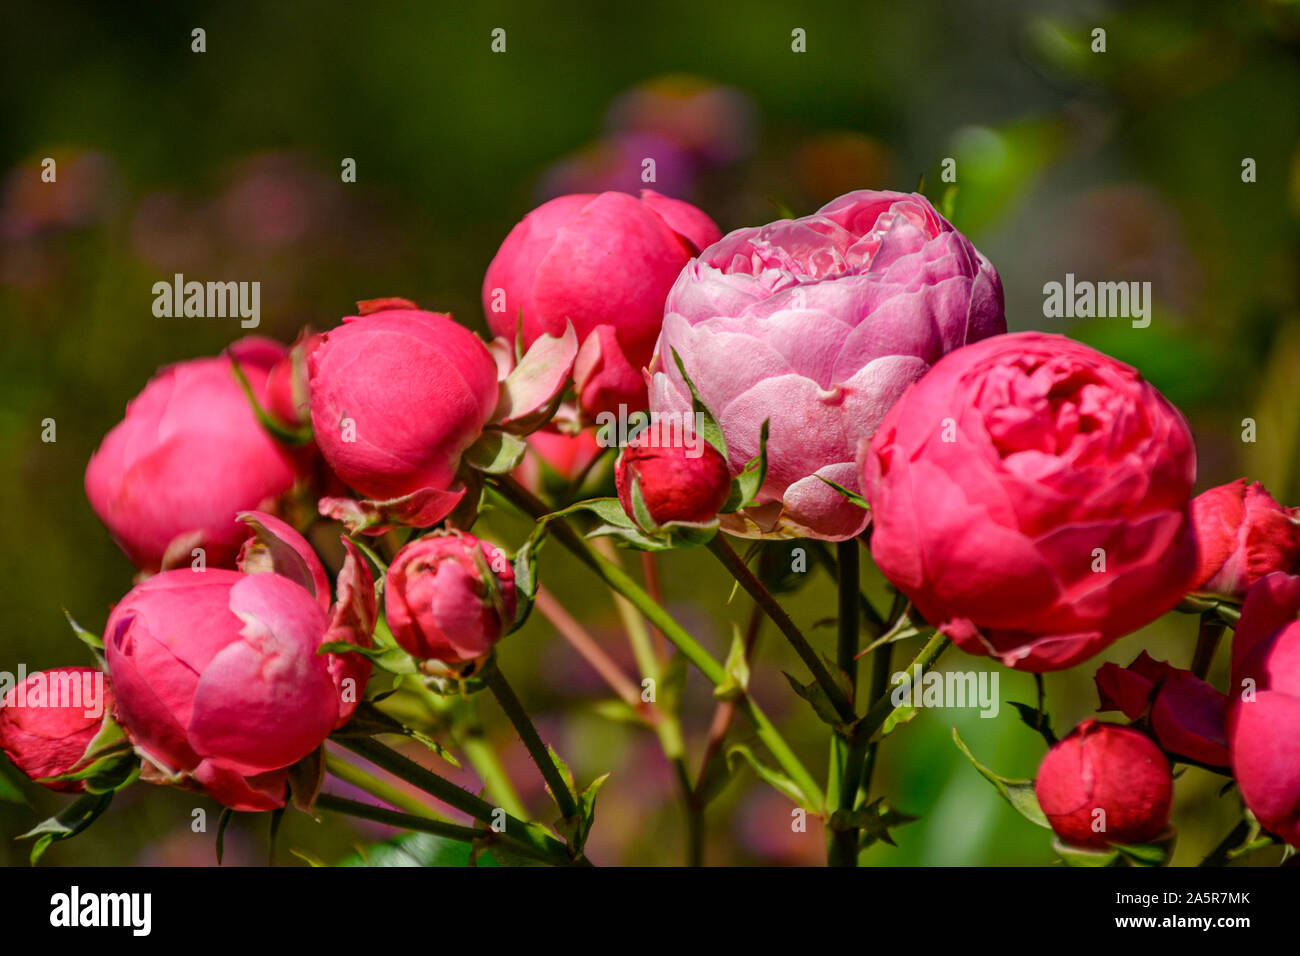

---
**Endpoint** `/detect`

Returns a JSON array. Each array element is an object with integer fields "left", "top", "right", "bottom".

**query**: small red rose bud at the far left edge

[{"left": 0, "top": 667, "right": 113, "bottom": 792}]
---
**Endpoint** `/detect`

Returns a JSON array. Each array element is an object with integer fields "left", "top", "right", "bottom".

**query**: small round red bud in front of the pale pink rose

[{"left": 614, "top": 428, "right": 731, "bottom": 531}]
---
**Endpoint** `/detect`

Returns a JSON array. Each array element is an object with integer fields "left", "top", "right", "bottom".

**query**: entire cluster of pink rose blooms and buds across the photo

[{"left": 10, "top": 174, "right": 1300, "bottom": 868}]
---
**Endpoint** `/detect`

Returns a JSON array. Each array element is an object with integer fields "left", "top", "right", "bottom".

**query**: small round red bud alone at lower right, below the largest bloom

[{"left": 1034, "top": 721, "right": 1174, "bottom": 849}]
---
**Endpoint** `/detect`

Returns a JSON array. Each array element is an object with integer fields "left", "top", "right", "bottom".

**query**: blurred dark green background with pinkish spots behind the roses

[{"left": 0, "top": 0, "right": 1300, "bottom": 865}]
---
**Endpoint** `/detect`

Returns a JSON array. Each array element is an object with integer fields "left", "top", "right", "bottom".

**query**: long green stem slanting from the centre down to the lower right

[{"left": 493, "top": 476, "right": 826, "bottom": 813}]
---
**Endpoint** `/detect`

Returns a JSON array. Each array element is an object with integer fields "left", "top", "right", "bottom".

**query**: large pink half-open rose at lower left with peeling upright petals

[{"left": 104, "top": 514, "right": 374, "bottom": 810}]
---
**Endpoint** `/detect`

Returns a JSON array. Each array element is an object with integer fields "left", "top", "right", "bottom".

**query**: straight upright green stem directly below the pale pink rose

[{"left": 826, "top": 540, "right": 866, "bottom": 866}]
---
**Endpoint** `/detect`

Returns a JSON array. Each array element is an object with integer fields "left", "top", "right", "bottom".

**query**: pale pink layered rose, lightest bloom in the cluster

[{"left": 650, "top": 190, "right": 1006, "bottom": 541}]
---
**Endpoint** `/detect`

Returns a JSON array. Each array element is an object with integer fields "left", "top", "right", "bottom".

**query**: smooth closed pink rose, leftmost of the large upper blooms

[{"left": 86, "top": 338, "right": 302, "bottom": 571}]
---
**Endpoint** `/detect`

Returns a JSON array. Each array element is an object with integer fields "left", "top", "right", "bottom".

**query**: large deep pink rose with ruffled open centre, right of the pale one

[{"left": 862, "top": 332, "right": 1196, "bottom": 671}]
